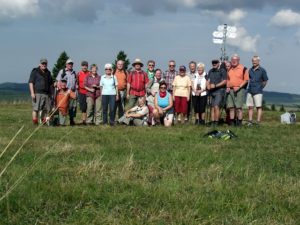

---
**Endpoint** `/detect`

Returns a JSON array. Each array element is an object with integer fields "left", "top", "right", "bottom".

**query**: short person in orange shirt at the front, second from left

[{"left": 55, "top": 79, "right": 76, "bottom": 126}]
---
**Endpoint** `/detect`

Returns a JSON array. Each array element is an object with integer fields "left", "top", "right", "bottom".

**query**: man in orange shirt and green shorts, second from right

[{"left": 226, "top": 54, "right": 249, "bottom": 126}]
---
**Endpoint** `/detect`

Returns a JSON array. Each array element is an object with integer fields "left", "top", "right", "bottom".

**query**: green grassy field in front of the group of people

[{"left": 0, "top": 105, "right": 300, "bottom": 225}]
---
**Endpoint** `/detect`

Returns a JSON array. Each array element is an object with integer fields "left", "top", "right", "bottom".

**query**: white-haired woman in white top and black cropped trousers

[{"left": 192, "top": 63, "right": 207, "bottom": 125}]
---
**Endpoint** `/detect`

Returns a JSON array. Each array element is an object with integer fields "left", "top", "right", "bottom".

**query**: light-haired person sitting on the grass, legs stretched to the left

[{"left": 118, "top": 97, "right": 149, "bottom": 126}]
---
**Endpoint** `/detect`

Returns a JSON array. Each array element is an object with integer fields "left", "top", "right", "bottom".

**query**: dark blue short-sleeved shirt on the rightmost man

[{"left": 248, "top": 66, "right": 269, "bottom": 94}]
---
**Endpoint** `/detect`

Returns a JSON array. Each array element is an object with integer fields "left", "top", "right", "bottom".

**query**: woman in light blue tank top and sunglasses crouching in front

[{"left": 153, "top": 81, "right": 174, "bottom": 127}]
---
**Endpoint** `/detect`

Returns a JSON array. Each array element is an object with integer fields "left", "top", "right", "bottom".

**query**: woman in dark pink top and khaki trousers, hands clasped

[{"left": 84, "top": 64, "right": 101, "bottom": 125}]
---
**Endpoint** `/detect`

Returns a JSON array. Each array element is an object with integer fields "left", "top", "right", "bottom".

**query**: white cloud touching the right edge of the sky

[{"left": 271, "top": 9, "right": 300, "bottom": 27}]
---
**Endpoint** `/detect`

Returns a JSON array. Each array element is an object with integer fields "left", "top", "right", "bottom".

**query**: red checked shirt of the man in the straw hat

[{"left": 127, "top": 70, "right": 149, "bottom": 96}]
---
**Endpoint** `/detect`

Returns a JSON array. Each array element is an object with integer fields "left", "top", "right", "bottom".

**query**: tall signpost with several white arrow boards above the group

[{"left": 212, "top": 24, "right": 237, "bottom": 61}]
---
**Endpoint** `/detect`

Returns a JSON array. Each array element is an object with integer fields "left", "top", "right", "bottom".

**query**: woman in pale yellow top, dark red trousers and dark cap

[{"left": 173, "top": 66, "right": 191, "bottom": 123}]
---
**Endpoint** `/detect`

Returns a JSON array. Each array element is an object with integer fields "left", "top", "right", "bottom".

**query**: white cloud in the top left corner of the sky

[{"left": 0, "top": 0, "right": 39, "bottom": 22}]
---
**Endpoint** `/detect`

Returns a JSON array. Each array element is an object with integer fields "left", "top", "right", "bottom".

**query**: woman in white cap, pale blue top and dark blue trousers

[{"left": 100, "top": 63, "right": 119, "bottom": 126}]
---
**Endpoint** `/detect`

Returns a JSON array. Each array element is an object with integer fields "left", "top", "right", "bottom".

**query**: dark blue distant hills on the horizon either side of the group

[{"left": 0, "top": 83, "right": 300, "bottom": 105}]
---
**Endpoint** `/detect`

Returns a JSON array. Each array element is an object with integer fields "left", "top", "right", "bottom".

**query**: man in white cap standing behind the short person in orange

[{"left": 56, "top": 59, "right": 77, "bottom": 126}]
